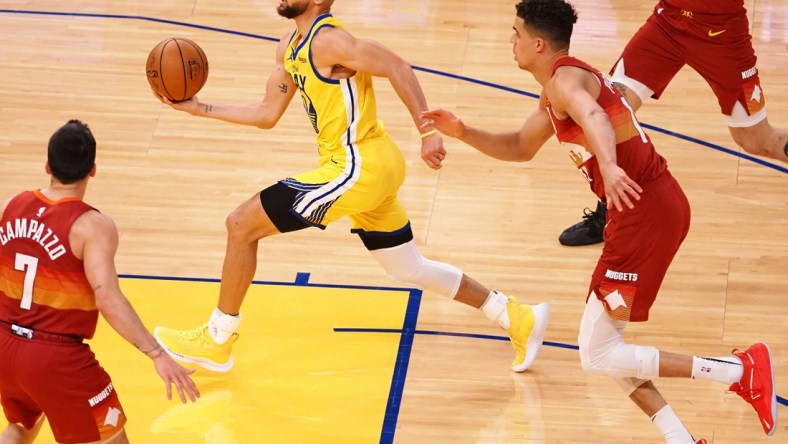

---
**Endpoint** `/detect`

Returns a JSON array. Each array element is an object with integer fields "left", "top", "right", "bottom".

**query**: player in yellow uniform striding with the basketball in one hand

[{"left": 155, "top": 0, "right": 549, "bottom": 372}]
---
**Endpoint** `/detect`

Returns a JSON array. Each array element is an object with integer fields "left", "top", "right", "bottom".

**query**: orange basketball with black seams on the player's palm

[{"left": 146, "top": 37, "right": 208, "bottom": 102}]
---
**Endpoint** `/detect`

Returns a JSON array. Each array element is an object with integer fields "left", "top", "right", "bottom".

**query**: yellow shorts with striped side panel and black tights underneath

[{"left": 260, "top": 133, "right": 413, "bottom": 250}]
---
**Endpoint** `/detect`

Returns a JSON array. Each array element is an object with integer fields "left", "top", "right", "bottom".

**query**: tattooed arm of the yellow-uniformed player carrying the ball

[{"left": 153, "top": 30, "right": 296, "bottom": 129}]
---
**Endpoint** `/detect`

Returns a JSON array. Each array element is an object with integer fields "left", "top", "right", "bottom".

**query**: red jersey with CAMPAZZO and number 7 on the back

[{"left": 0, "top": 190, "right": 98, "bottom": 339}]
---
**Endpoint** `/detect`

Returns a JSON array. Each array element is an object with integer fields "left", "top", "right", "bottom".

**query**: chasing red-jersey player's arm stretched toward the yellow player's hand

[{"left": 421, "top": 94, "right": 554, "bottom": 162}]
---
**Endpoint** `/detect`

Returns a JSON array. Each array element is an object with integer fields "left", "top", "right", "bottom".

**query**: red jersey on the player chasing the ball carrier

[{"left": 547, "top": 56, "right": 667, "bottom": 200}]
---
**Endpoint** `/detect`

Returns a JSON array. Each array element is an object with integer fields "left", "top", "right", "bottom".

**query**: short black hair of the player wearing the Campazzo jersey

[{"left": 47, "top": 119, "right": 96, "bottom": 184}]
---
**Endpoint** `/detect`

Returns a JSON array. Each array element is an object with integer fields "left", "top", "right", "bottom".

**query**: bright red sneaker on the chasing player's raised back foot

[{"left": 730, "top": 342, "right": 777, "bottom": 435}]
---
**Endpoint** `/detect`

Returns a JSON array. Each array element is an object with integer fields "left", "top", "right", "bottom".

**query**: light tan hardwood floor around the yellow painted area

[{"left": 0, "top": 0, "right": 788, "bottom": 444}]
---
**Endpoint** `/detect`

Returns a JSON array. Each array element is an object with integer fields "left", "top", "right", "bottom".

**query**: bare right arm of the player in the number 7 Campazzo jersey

[{"left": 76, "top": 211, "right": 200, "bottom": 403}]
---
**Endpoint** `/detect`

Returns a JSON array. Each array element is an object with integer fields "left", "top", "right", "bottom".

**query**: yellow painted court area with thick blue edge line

[{"left": 104, "top": 275, "right": 421, "bottom": 443}]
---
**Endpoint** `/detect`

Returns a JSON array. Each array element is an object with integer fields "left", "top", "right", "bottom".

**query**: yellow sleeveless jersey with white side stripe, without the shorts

[{"left": 284, "top": 13, "right": 382, "bottom": 156}]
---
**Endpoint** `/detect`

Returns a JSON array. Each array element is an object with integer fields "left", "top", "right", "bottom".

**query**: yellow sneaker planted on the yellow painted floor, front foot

[{"left": 153, "top": 324, "right": 238, "bottom": 372}]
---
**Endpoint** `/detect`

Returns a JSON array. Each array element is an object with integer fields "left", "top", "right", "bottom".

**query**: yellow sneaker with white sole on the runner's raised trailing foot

[{"left": 506, "top": 296, "right": 550, "bottom": 372}]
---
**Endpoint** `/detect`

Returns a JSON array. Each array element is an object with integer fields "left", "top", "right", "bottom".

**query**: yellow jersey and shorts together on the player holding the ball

[{"left": 279, "top": 14, "right": 410, "bottom": 246}]
